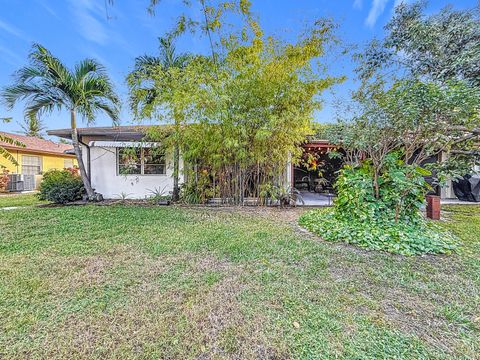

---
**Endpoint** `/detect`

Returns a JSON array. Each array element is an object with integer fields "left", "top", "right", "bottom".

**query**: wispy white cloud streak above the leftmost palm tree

[{"left": 70, "top": 0, "right": 109, "bottom": 45}]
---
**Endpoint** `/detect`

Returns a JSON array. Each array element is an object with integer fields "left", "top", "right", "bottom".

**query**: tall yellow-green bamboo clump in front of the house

[{"left": 124, "top": 0, "right": 342, "bottom": 204}]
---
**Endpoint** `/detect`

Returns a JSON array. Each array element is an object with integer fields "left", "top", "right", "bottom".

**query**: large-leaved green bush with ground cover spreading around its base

[{"left": 299, "top": 154, "right": 457, "bottom": 255}]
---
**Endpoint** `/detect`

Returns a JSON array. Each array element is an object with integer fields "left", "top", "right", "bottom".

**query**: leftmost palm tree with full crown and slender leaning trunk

[{"left": 1, "top": 44, "right": 120, "bottom": 199}]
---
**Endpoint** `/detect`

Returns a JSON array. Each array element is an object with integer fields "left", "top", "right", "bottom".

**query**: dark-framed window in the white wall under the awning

[{"left": 117, "top": 148, "right": 166, "bottom": 175}]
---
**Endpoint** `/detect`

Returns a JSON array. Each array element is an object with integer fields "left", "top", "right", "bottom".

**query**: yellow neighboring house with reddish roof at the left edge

[{"left": 0, "top": 131, "right": 77, "bottom": 185}]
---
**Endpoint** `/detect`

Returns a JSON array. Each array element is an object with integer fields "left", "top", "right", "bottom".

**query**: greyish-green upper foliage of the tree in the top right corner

[{"left": 358, "top": 1, "right": 480, "bottom": 87}]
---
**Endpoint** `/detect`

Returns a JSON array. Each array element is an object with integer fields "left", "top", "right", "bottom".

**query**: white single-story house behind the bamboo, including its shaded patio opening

[{"left": 48, "top": 125, "right": 455, "bottom": 199}]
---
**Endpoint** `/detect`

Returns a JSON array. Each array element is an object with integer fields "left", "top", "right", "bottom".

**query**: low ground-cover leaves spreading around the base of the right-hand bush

[{"left": 299, "top": 209, "right": 457, "bottom": 255}]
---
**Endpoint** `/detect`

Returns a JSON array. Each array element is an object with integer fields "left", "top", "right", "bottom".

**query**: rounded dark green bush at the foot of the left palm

[{"left": 39, "top": 170, "right": 85, "bottom": 204}]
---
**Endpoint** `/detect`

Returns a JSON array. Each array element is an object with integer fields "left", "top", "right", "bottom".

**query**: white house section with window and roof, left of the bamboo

[{"left": 48, "top": 126, "right": 183, "bottom": 199}]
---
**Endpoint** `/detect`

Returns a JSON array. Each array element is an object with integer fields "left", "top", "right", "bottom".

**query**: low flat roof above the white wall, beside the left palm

[{"left": 47, "top": 125, "right": 153, "bottom": 140}]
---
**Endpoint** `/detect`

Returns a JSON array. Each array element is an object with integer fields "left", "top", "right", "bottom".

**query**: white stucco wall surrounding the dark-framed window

[{"left": 86, "top": 146, "right": 183, "bottom": 199}]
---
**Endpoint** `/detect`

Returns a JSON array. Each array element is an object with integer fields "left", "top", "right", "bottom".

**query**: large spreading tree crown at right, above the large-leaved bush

[{"left": 355, "top": 1, "right": 480, "bottom": 175}]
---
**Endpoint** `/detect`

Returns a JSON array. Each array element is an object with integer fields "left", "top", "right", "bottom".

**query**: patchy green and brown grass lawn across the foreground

[{"left": 0, "top": 205, "right": 480, "bottom": 359}]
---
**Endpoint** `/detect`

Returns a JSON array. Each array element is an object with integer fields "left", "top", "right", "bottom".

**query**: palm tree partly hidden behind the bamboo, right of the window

[{"left": 129, "top": 36, "right": 192, "bottom": 201}]
